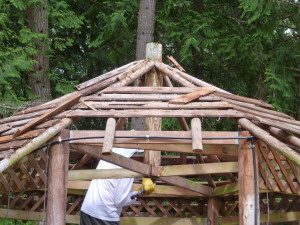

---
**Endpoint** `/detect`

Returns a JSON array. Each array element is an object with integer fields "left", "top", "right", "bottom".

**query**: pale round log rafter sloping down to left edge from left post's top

[{"left": 0, "top": 118, "right": 73, "bottom": 173}]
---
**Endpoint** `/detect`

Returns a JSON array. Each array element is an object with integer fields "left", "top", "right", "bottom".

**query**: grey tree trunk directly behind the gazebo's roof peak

[{"left": 131, "top": 0, "right": 156, "bottom": 130}]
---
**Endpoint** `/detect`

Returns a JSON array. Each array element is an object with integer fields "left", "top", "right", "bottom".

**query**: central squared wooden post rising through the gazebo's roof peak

[{"left": 145, "top": 43, "right": 163, "bottom": 166}]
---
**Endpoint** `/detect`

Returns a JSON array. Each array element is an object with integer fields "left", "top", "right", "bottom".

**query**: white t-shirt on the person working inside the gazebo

[{"left": 81, "top": 148, "right": 142, "bottom": 221}]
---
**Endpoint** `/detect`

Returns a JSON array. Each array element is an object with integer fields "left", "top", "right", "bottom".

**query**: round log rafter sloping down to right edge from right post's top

[{"left": 238, "top": 118, "right": 300, "bottom": 166}]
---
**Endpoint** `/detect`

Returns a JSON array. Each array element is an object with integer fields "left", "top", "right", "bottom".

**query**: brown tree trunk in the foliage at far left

[{"left": 27, "top": 0, "right": 51, "bottom": 100}]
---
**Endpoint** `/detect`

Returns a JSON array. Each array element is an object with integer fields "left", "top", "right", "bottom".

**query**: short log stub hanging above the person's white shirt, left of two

[{"left": 102, "top": 118, "right": 116, "bottom": 155}]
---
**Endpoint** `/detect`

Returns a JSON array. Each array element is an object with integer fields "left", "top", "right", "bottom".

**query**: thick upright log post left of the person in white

[{"left": 47, "top": 130, "right": 70, "bottom": 225}]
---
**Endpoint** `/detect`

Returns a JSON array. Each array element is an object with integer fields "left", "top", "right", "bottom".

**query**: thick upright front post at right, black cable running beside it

[{"left": 238, "top": 132, "right": 259, "bottom": 225}]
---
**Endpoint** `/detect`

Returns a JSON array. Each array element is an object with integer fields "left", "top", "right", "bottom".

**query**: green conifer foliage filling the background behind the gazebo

[{"left": 0, "top": 0, "right": 300, "bottom": 124}]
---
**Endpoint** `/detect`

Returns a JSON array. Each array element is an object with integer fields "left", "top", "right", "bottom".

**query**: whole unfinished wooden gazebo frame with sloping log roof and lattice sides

[{"left": 0, "top": 44, "right": 300, "bottom": 225}]
